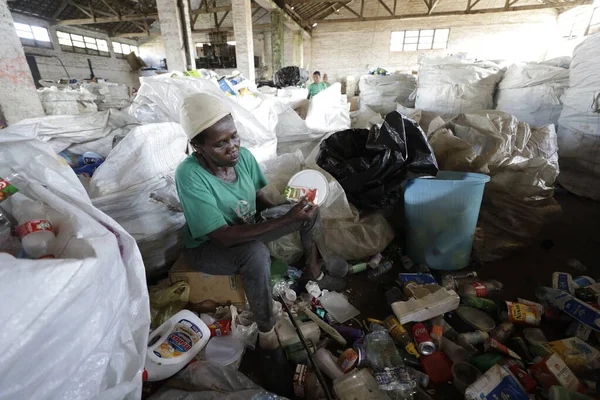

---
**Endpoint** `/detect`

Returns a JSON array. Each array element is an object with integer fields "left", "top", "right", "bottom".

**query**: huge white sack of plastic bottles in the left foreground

[{"left": 0, "top": 126, "right": 150, "bottom": 400}]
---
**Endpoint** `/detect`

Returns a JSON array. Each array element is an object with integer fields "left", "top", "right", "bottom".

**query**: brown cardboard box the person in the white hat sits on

[{"left": 169, "top": 256, "right": 246, "bottom": 306}]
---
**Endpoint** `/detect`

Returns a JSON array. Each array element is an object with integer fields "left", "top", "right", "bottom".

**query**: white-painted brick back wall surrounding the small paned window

[{"left": 311, "top": 8, "right": 557, "bottom": 80}]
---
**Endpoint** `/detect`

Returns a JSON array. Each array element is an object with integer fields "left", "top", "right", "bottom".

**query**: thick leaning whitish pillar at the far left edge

[{"left": 0, "top": 0, "right": 44, "bottom": 125}]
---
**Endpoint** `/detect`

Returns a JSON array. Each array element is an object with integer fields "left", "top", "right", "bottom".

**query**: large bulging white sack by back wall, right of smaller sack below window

[{"left": 415, "top": 58, "right": 502, "bottom": 118}]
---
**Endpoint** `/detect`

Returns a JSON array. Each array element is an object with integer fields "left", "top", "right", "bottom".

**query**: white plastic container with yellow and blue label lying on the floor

[{"left": 146, "top": 310, "right": 210, "bottom": 381}]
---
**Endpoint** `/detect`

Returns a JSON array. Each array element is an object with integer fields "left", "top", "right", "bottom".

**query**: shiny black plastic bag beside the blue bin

[{"left": 317, "top": 111, "right": 438, "bottom": 211}]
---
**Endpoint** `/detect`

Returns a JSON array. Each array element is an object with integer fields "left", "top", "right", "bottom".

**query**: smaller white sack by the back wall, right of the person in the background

[{"left": 358, "top": 74, "right": 417, "bottom": 115}]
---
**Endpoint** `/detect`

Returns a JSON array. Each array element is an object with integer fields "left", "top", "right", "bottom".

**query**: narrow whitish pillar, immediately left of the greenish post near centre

[{"left": 231, "top": 0, "right": 256, "bottom": 81}]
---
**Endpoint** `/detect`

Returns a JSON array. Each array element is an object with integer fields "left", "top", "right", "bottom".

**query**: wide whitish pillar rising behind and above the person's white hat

[{"left": 156, "top": 0, "right": 191, "bottom": 71}]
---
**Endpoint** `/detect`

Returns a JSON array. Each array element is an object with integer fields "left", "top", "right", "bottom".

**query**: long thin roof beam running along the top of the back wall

[{"left": 310, "top": 0, "right": 593, "bottom": 24}]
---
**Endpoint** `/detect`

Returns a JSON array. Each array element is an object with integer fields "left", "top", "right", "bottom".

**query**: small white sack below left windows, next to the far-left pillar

[{"left": 38, "top": 86, "right": 98, "bottom": 115}]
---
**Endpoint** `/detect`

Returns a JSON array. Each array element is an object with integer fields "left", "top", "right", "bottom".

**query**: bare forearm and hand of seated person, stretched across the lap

[{"left": 208, "top": 199, "right": 317, "bottom": 247}]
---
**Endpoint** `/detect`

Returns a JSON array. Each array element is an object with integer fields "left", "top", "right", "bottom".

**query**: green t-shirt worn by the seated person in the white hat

[{"left": 175, "top": 147, "right": 267, "bottom": 248}]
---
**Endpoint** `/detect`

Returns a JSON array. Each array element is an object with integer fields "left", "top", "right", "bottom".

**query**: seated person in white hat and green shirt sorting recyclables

[{"left": 175, "top": 93, "right": 348, "bottom": 349}]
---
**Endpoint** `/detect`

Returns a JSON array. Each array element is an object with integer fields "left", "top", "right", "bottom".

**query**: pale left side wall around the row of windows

[{"left": 13, "top": 13, "right": 139, "bottom": 87}]
